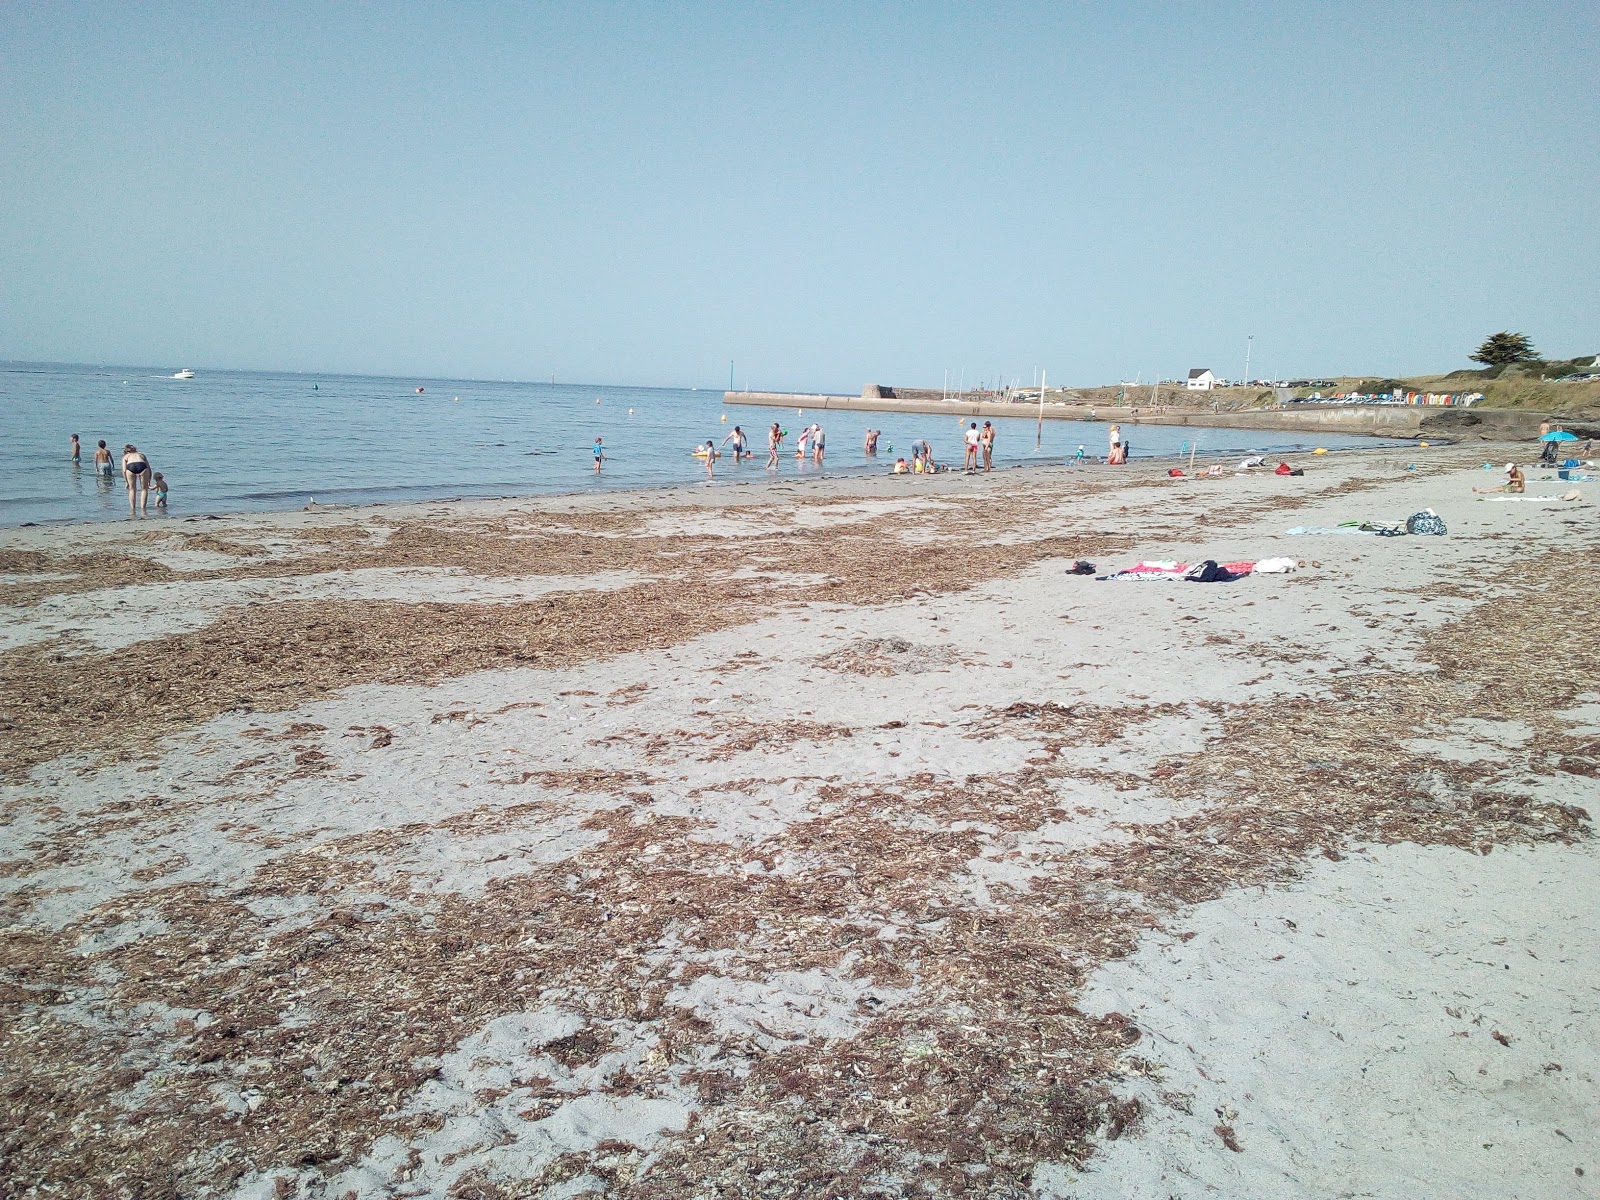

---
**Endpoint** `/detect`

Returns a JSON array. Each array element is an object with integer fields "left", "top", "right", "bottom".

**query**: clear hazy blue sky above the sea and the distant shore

[{"left": 0, "top": 0, "right": 1600, "bottom": 390}]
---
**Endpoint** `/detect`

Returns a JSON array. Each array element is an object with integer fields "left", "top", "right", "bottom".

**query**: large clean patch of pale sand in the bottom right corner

[{"left": 1062, "top": 838, "right": 1600, "bottom": 1200}]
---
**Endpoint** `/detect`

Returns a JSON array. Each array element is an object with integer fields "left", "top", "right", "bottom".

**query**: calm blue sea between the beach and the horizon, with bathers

[{"left": 0, "top": 363, "right": 1414, "bottom": 525}]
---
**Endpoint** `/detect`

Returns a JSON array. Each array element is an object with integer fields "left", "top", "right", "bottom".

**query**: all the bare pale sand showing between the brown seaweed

[{"left": 0, "top": 448, "right": 1600, "bottom": 1200}]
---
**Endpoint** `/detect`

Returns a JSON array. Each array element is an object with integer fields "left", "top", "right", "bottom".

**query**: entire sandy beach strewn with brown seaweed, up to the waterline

[{"left": 0, "top": 445, "right": 1600, "bottom": 1200}]
